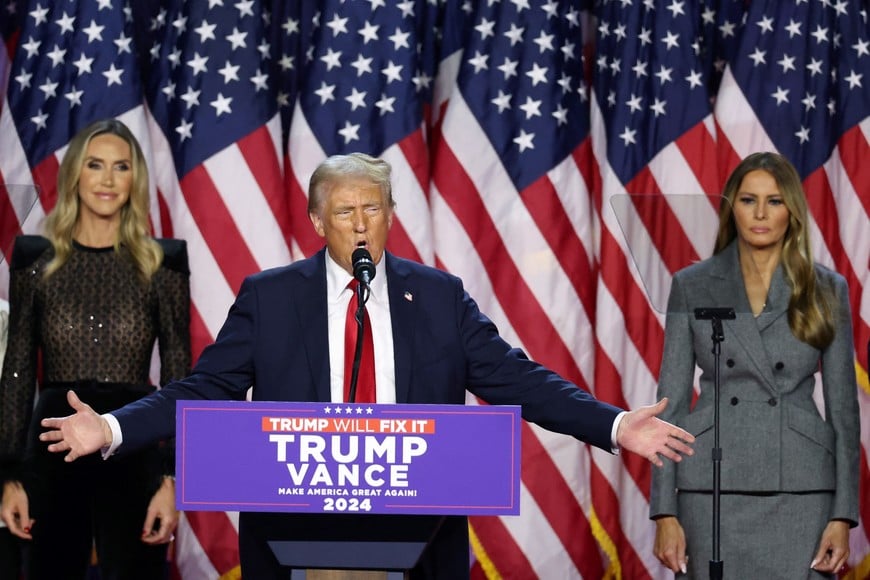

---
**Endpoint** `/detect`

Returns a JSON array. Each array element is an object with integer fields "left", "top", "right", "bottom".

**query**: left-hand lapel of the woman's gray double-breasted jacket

[{"left": 708, "top": 243, "right": 776, "bottom": 392}]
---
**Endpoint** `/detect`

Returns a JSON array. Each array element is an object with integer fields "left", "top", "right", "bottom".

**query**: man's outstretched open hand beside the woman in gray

[{"left": 616, "top": 398, "right": 695, "bottom": 467}]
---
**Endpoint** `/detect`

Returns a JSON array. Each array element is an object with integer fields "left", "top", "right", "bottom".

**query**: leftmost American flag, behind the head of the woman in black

[{"left": 0, "top": 1, "right": 152, "bottom": 300}]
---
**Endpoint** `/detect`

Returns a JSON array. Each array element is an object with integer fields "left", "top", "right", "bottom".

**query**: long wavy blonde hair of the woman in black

[{"left": 45, "top": 119, "right": 163, "bottom": 283}]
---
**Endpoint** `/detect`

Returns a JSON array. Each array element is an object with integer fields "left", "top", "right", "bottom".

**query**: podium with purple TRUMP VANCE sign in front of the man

[{"left": 176, "top": 401, "right": 522, "bottom": 580}]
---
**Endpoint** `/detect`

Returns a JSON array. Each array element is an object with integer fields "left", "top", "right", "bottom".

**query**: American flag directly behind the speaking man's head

[{"left": 282, "top": 0, "right": 442, "bottom": 263}]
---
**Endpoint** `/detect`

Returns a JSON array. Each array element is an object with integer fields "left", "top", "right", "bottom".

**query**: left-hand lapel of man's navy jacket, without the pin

[{"left": 291, "top": 249, "right": 332, "bottom": 401}]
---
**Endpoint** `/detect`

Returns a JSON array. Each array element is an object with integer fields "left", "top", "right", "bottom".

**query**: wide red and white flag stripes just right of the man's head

[{"left": 430, "top": 76, "right": 604, "bottom": 578}]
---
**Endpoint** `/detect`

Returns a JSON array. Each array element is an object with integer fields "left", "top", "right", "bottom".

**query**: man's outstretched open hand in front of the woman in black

[{"left": 39, "top": 391, "right": 112, "bottom": 462}]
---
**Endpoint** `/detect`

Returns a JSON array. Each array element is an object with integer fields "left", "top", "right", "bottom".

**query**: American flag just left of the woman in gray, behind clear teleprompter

[{"left": 591, "top": 2, "right": 721, "bottom": 578}]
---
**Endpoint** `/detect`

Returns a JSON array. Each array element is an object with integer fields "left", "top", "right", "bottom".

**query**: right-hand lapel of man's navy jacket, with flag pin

[{"left": 384, "top": 253, "right": 417, "bottom": 403}]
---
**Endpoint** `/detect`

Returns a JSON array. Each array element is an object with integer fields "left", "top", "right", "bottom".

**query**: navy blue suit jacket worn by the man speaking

[{"left": 113, "top": 249, "right": 621, "bottom": 577}]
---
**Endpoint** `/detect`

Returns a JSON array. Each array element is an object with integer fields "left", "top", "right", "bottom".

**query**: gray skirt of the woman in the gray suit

[{"left": 677, "top": 492, "right": 834, "bottom": 580}]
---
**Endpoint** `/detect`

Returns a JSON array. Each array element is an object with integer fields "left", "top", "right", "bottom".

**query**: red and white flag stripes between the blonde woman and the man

[{"left": 148, "top": 110, "right": 290, "bottom": 579}]
